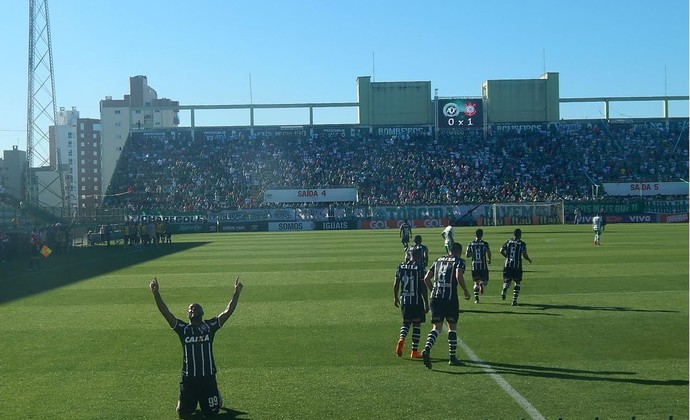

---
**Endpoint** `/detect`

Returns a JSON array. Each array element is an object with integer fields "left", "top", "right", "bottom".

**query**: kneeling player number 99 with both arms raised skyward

[{"left": 149, "top": 276, "right": 243, "bottom": 418}]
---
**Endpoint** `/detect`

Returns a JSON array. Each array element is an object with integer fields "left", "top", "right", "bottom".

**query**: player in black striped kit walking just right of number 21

[{"left": 422, "top": 242, "right": 470, "bottom": 369}]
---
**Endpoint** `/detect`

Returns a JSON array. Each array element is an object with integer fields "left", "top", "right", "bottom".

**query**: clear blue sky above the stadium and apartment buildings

[{"left": 0, "top": 0, "right": 689, "bottom": 150}]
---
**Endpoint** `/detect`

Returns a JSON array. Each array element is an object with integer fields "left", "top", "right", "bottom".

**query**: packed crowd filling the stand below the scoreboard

[{"left": 105, "top": 124, "right": 688, "bottom": 212}]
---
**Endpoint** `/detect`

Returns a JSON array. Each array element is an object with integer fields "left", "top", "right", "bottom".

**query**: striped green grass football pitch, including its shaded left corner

[{"left": 0, "top": 224, "right": 689, "bottom": 419}]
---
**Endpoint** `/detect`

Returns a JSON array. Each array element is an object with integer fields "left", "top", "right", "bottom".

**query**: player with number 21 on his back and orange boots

[{"left": 393, "top": 248, "right": 429, "bottom": 359}]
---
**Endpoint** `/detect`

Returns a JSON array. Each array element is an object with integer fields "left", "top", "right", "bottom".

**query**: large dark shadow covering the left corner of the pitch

[{"left": 0, "top": 242, "right": 207, "bottom": 304}]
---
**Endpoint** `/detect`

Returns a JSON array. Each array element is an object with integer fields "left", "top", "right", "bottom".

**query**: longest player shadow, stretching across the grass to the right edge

[{"left": 460, "top": 360, "right": 688, "bottom": 386}]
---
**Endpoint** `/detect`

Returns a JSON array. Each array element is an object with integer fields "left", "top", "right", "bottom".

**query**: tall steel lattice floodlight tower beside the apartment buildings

[{"left": 24, "top": 0, "right": 65, "bottom": 217}]
